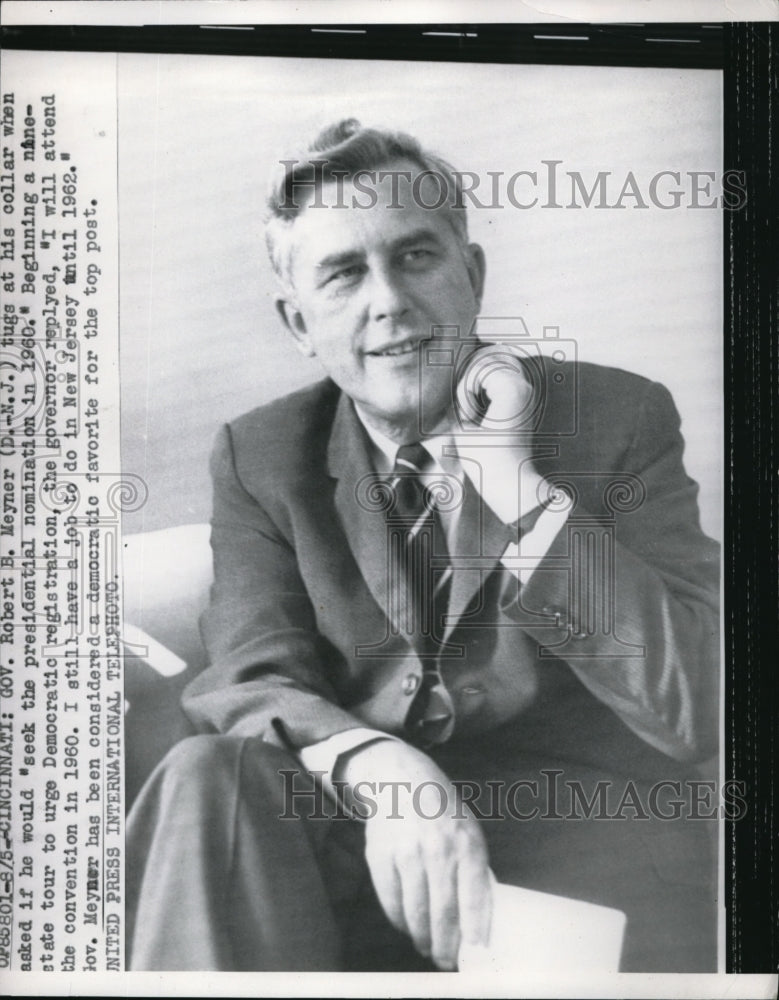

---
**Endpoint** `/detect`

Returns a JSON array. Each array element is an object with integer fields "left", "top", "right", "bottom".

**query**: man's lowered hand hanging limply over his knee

[{"left": 339, "top": 740, "right": 492, "bottom": 969}]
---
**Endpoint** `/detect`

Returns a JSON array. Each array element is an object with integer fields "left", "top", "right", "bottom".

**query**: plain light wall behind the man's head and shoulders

[{"left": 118, "top": 54, "right": 723, "bottom": 538}]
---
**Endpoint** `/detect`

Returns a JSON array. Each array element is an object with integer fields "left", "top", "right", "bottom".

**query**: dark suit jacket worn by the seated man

[{"left": 184, "top": 363, "right": 719, "bottom": 778}]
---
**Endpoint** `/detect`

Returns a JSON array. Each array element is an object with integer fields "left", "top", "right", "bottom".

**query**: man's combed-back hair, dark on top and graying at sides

[{"left": 265, "top": 118, "right": 468, "bottom": 285}]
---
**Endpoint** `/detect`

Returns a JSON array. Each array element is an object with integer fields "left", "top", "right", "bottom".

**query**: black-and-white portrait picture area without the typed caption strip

[{"left": 118, "top": 37, "right": 724, "bottom": 972}]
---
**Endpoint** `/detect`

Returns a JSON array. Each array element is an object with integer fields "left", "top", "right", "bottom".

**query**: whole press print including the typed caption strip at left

[{"left": 0, "top": 5, "right": 770, "bottom": 996}]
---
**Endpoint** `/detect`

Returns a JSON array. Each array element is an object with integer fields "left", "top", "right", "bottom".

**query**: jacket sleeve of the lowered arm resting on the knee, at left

[{"left": 183, "top": 427, "right": 365, "bottom": 748}]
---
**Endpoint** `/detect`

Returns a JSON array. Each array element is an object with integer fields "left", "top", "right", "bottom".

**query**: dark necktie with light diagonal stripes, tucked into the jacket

[{"left": 390, "top": 443, "right": 454, "bottom": 746}]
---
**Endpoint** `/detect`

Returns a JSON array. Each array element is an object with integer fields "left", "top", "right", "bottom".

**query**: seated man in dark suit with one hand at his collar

[{"left": 127, "top": 121, "right": 719, "bottom": 971}]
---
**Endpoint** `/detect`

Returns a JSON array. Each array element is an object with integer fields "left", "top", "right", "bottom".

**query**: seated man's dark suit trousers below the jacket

[{"left": 126, "top": 735, "right": 716, "bottom": 972}]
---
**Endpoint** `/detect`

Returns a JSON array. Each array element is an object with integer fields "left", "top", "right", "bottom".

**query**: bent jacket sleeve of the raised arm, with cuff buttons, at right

[{"left": 503, "top": 383, "right": 720, "bottom": 761}]
